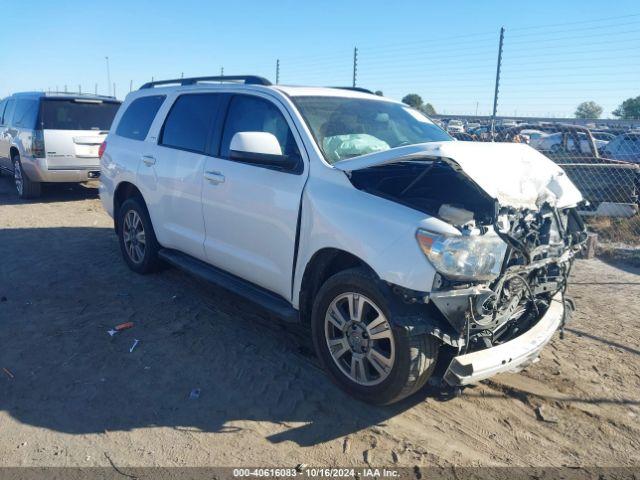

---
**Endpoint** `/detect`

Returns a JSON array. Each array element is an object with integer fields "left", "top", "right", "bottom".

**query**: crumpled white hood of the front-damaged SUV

[{"left": 333, "top": 141, "right": 582, "bottom": 210}]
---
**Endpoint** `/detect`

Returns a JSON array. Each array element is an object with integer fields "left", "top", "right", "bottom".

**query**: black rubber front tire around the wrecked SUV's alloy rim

[{"left": 311, "top": 268, "right": 440, "bottom": 405}]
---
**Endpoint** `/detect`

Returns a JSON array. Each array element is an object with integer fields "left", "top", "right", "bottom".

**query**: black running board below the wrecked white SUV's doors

[{"left": 158, "top": 248, "right": 300, "bottom": 323}]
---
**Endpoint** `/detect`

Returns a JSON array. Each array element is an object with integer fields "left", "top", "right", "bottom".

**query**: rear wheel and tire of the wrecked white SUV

[{"left": 117, "top": 197, "right": 162, "bottom": 274}]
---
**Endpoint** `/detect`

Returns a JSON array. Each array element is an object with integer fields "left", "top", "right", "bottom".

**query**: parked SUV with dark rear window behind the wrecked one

[{"left": 0, "top": 92, "right": 120, "bottom": 198}]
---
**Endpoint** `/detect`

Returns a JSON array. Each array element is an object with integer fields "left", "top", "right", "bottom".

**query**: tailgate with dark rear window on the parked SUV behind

[{"left": 39, "top": 97, "right": 120, "bottom": 170}]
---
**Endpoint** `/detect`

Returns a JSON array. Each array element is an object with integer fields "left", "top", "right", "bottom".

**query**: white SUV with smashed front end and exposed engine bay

[{"left": 101, "top": 76, "right": 584, "bottom": 404}]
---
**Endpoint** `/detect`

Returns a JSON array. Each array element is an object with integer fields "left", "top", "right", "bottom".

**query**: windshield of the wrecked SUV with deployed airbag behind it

[{"left": 293, "top": 97, "right": 452, "bottom": 164}]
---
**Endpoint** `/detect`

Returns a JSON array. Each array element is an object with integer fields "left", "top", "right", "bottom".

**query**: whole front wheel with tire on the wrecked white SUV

[{"left": 311, "top": 268, "right": 439, "bottom": 405}]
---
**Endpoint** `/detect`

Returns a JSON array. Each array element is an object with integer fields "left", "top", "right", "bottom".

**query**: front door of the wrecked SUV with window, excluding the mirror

[{"left": 202, "top": 94, "right": 308, "bottom": 300}]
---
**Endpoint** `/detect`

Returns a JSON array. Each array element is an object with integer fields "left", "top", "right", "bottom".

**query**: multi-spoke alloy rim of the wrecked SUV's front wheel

[{"left": 324, "top": 292, "right": 395, "bottom": 386}]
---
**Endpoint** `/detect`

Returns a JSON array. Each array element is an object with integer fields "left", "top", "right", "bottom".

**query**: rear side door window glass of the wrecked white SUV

[{"left": 160, "top": 93, "right": 223, "bottom": 153}]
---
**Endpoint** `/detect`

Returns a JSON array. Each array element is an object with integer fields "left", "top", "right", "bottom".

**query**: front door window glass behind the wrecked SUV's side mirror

[{"left": 220, "top": 95, "right": 300, "bottom": 158}]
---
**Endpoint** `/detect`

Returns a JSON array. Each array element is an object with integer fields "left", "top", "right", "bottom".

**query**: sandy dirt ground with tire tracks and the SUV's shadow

[{"left": 0, "top": 177, "right": 640, "bottom": 467}]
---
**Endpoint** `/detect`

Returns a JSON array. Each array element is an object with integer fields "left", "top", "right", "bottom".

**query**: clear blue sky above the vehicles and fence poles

[{"left": 0, "top": 0, "right": 640, "bottom": 116}]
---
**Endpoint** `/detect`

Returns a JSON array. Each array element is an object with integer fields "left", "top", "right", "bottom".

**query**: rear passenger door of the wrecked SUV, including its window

[{"left": 138, "top": 93, "right": 225, "bottom": 260}]
